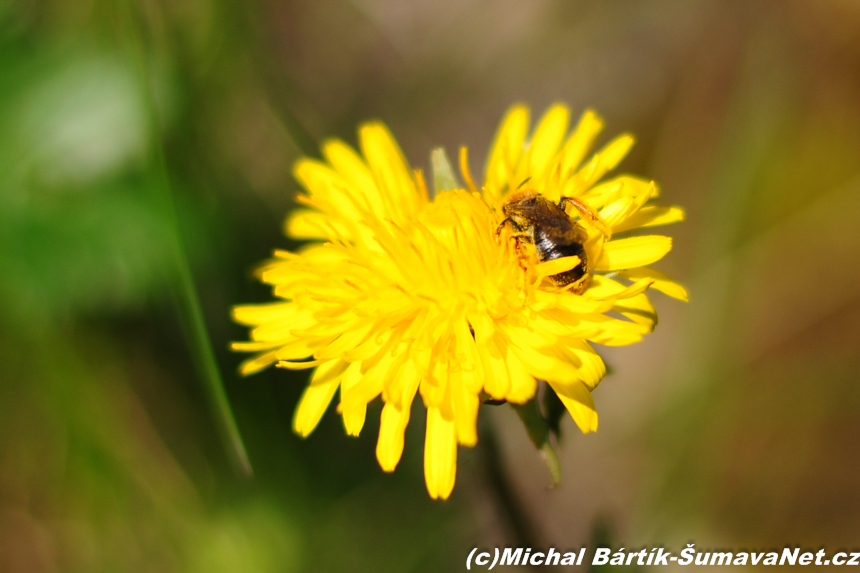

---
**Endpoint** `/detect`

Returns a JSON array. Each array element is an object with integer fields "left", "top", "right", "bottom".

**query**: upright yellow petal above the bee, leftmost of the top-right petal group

[{"left": 484, "top": 105, "right": 529, "bottom": 200}]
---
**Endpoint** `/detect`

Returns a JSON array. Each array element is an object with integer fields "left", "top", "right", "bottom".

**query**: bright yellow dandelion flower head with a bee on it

[{"left": 233, "top": 105, "right": 686, "bottom": 499}]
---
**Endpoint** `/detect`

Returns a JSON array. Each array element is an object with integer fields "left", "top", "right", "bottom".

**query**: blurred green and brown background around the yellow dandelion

[{"left": 5, "top": 0, "right": 860, "bottom": 573}]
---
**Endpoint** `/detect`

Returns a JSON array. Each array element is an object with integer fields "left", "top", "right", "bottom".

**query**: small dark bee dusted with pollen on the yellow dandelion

[{"left": 496, "top": 190, "right": 612, "bottom": 294}]
